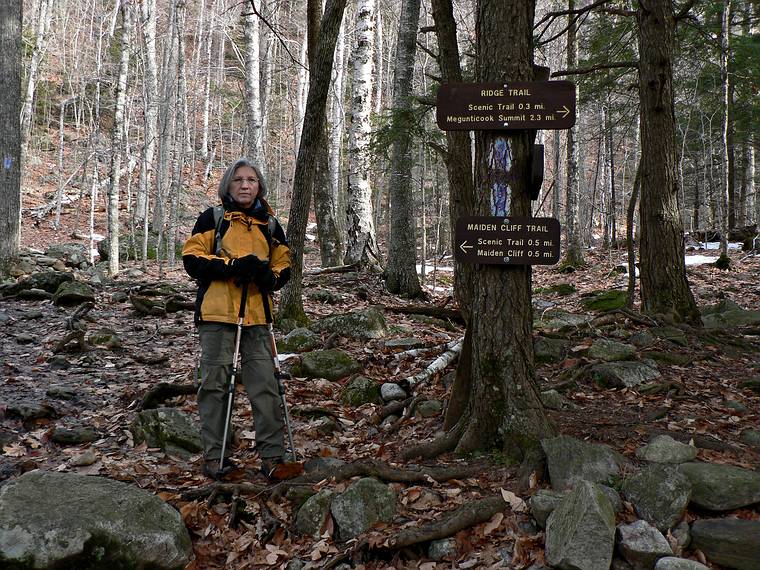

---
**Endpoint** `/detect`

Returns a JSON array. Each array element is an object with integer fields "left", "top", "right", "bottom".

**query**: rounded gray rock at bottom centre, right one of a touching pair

[{"left": 330, "top": 477, "right": 396, "bottom": 541}]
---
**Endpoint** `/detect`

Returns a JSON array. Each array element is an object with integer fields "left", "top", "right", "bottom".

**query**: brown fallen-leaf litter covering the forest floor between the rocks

[{"left": 0, "top": 197, "right": 760, "bottom": 570}]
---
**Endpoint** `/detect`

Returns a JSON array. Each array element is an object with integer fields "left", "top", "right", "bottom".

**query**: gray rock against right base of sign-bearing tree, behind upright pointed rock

[{"left": 541, "top": 435, "right": 625, "bottom": 490}]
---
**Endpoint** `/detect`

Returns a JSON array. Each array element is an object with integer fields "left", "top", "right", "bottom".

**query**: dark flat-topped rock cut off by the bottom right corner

[{"left": 691, "top": 519, "right": 760, "bottom": 570}]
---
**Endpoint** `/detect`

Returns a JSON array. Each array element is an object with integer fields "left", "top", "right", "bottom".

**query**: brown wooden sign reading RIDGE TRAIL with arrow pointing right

[{"left": 436, "top": 81, "right": 575, "bottom": 131}]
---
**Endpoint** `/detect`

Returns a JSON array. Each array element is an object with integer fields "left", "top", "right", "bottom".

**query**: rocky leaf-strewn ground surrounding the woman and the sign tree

[{"left": 0, "top": 242, "right": 760, "bottom": 569}]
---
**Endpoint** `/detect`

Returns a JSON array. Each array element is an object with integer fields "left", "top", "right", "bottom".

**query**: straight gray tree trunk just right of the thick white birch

[{"left": 385, "top": 0, "right": 424, "bottom": 298}]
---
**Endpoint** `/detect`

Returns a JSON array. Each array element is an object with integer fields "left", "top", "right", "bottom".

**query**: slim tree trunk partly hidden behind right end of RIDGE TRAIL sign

[{"left": 561, "top": 0, "right": 584, "bottom": 268}]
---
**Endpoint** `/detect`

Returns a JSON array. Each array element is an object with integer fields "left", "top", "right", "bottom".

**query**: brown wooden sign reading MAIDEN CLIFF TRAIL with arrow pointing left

[{"left": 454, "top": 216, "right": 560, "bottom": 265}]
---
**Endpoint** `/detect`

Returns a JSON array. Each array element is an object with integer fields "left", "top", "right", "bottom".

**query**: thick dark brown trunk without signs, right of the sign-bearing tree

[{"left": 637, "top": 0, "right": 700, "bottom": 324}]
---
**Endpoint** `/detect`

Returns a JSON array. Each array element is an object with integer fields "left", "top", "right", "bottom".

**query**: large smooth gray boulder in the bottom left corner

[{"left": 0, "top": 471, "right": 192, "bottom": 570}]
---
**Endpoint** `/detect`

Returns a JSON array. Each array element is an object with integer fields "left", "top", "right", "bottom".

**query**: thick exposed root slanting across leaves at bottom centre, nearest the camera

[{"left": 387, "top": 495, "right": 509, "bottom": 548}]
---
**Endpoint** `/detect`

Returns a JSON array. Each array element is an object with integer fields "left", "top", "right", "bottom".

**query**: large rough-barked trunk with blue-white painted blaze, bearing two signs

[{"left": 410, "top": 0, "right": 554, "bottom": 459}]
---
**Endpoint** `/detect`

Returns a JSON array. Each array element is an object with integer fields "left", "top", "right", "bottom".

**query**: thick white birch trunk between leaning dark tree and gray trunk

[{"left": 344, "top": 0, "right": 380, "bottom": 265}]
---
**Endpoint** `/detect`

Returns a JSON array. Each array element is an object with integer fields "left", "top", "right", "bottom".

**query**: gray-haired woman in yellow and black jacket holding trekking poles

[{"left": 182, "top": 158, "right": 290, "bottom": 479}]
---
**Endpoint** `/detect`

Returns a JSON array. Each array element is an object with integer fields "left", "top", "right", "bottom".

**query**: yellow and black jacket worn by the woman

[{"left": 182, "top": 199, "right": 290, "bottom": 326}]
